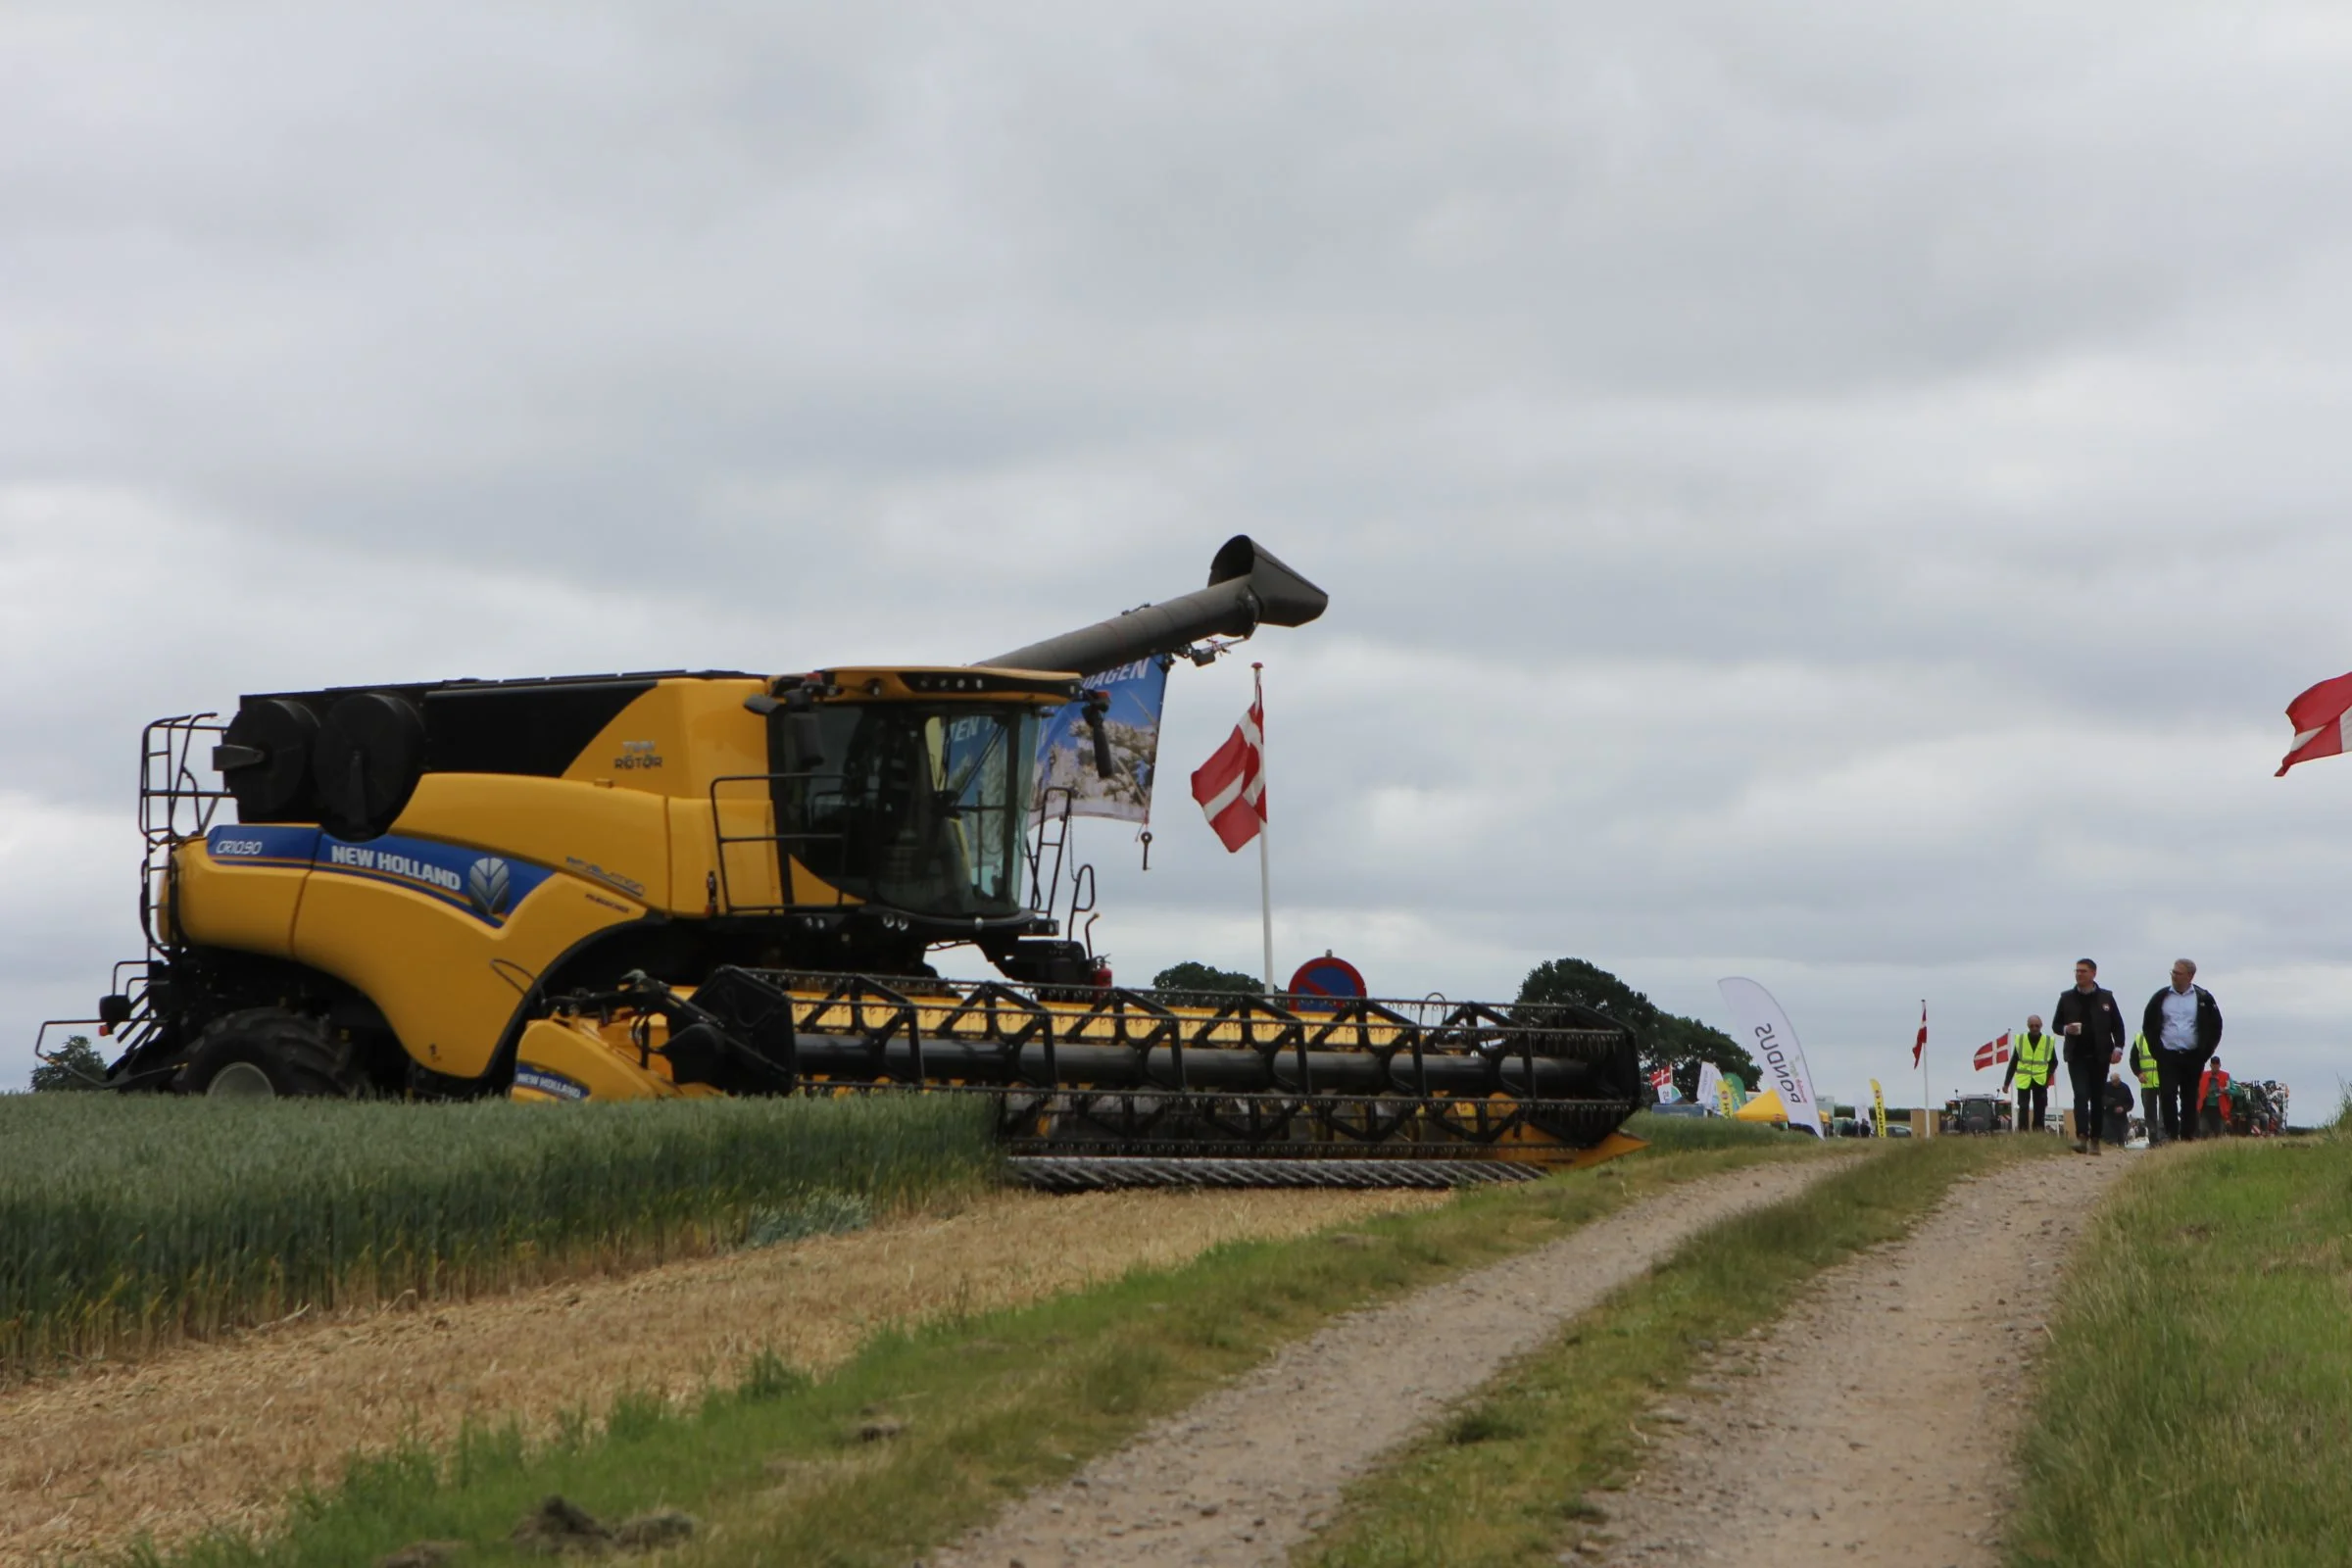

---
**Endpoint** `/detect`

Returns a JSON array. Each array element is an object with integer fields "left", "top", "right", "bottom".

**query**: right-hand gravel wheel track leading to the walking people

[{"left": 1594, "top": 1152, "right": 2145, "bottom": 1568}]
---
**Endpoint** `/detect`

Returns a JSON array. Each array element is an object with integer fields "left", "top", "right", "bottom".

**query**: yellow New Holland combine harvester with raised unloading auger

[{"left": 50, "top": 538, "right": 1637, "bottom": 1185}]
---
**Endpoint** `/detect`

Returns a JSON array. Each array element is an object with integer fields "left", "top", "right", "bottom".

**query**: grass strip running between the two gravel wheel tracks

[{"left": 1292, "top": 1138, "right": 2060, "bottom": 1568}]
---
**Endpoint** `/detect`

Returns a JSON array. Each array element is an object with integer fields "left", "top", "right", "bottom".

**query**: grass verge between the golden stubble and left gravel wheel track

[{"left": 131, "top": 1119, "right": 1818, "bottom": 1568}]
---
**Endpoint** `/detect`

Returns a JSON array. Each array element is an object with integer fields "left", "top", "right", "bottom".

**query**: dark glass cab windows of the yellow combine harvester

[{"left": 771, "top": 703, "right": 1037, "bottom": 917}]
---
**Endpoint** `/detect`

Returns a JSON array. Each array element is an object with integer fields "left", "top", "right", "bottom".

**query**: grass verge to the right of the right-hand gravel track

[{"left": 2011, "top": 1133, "right": 2352, "bottom": 1568}]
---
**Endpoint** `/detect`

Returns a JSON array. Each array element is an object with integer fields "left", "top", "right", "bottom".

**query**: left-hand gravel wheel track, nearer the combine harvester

[{"left": 929, "top": 1159, "right": 1844, "bottom": 1568}]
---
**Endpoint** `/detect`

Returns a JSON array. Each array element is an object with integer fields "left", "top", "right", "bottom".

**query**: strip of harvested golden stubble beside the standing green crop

[{"left": 0, "top": 1192, "right": 1445, "bottom": 1568}]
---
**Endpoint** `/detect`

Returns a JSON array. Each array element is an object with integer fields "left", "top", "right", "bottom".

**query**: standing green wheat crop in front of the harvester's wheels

[{"left": 0, "top": 1093, "right": 1000, "bottom": 1375}]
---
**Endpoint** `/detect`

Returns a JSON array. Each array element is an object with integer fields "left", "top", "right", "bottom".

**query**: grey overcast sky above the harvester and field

[{"left": 0, "top": 0, "right": 2352, "bottom": 1119}]
